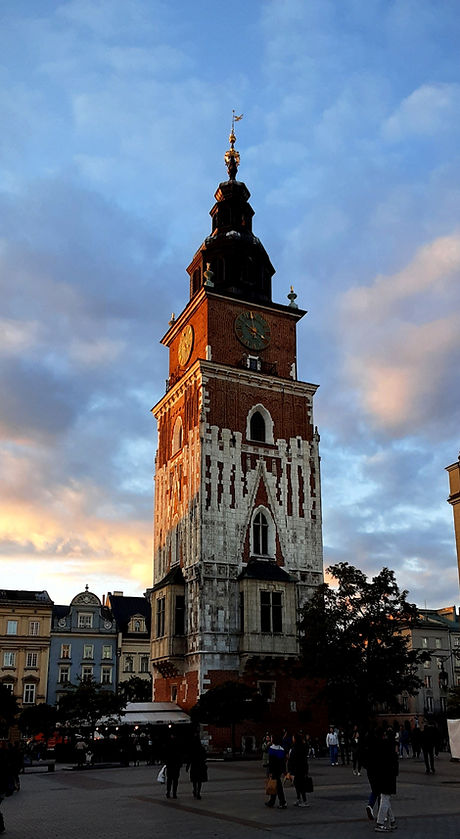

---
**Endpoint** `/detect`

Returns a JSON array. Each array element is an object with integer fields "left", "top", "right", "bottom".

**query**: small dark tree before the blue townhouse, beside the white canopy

[{"left": 58, "top": 678, "right": 126, "bottom": 736}]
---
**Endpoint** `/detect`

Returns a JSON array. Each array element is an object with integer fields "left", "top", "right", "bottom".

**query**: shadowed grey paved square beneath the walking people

[{"left": 2, "top": 754, "right": 460, "bottom": 839}]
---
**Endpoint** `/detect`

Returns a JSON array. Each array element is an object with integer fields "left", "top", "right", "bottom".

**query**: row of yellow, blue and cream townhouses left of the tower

[{"left": 0, "top": 586, "right": 151, "bottom": 706}]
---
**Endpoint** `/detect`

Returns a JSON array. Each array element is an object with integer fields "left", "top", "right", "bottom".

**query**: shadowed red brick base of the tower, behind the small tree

[{"left": 154, "top": 662, "right": 329, "bottom": 755}]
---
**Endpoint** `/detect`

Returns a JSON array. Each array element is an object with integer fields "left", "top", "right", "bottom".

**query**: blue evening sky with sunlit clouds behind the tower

[{"left": 0, "top": 0, "right": 460, "bottom": 608}]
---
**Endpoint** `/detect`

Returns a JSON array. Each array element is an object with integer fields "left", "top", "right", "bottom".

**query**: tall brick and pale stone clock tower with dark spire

[{"left": 149, "top": 127, "right": 323, "bottom": 740}]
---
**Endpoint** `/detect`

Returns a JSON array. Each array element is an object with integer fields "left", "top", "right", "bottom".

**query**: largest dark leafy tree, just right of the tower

[{"left": 300, "top": 562, "right": 421, "bottom": 724}]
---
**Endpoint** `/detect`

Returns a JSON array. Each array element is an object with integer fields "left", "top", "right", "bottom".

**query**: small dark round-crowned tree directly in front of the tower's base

[{"left": 190, "top": 681, "right": 266, "bottom": 753}]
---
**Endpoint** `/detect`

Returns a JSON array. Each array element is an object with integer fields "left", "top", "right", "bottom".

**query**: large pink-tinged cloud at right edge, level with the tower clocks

[{"left": 341, "top": 234, "right": 460, "bottom": 436}]
